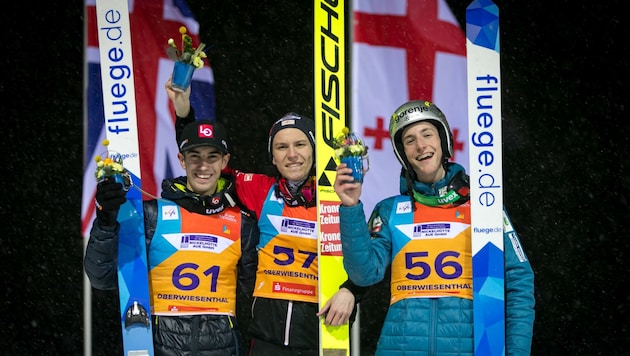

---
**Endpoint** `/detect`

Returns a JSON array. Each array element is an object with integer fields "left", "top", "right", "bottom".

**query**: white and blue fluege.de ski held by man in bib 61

[{"left": 96, "top": 0, "right": 153, "bottom": 356}]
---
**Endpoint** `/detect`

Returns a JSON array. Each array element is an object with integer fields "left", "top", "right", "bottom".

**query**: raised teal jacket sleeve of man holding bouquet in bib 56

[{"left": 339, "top": 200, "right": 392, "bottom": 287}]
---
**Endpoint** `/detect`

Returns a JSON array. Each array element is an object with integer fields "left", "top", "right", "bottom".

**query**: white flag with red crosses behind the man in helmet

[{"left": 351, "top": 0, "right": 468, "bottom": 216}]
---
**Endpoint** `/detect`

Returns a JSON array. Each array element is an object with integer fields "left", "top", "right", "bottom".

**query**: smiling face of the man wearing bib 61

[{"left": 177, "top": 146, "right": 230, "bottom": 195}]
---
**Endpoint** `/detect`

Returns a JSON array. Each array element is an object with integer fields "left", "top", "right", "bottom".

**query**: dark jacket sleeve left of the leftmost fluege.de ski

[{"left": 83, "top": 219, "right": 120, "bottom": 290}]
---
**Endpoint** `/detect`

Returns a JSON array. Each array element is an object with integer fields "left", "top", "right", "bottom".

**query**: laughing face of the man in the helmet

[{"left": 401, "top": 121, "right": 445, "bottom": 183}]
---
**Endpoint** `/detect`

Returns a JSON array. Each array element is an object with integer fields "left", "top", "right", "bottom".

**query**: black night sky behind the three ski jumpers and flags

[{"left": 0, "top": 0, "right": 630, "bottom": 355}]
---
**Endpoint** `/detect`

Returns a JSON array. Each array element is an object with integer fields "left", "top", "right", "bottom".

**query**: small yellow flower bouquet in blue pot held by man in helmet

[{"left": 333, "top": 127, "right": 370, "bottom": 183}]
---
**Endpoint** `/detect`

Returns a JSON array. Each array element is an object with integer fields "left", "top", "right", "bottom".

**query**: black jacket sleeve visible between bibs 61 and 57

[{"left": 238, "top": 212, "right": 260, "bottom": 299}]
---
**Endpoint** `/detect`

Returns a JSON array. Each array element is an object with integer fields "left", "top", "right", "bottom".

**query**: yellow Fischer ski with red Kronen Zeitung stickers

[{"left": 314, "top": 0, "right": 350, "bottom": 356}]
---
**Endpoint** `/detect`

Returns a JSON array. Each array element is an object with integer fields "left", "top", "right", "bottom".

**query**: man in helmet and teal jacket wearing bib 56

[{"left": 334, "top": 100, "right": 534, "bottom": 356}]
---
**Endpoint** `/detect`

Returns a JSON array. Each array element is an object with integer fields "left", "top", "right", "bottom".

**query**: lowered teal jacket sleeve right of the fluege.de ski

[{"left": 503, "top": 211, "right": 535, "bottom": 355}]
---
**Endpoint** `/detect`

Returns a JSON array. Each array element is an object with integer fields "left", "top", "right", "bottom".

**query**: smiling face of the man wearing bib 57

[{"left": 271, "top": 128, "right": 314, "bottom": 182}]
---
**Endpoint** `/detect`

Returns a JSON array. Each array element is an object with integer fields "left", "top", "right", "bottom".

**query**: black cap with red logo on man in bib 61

[{"left": 177, "top": 120, "right": 228, "bottom": 153}]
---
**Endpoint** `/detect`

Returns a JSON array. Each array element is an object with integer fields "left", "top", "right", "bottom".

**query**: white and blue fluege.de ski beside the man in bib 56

[{"left": 466, "top": 0, "right": 505, "bottom": 356}]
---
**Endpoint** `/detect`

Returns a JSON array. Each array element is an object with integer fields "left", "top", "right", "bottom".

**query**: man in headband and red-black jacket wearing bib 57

[{"left": 166, "top": 83, "right": 366, "bottom": 356}]
